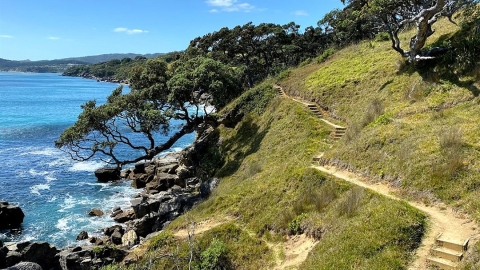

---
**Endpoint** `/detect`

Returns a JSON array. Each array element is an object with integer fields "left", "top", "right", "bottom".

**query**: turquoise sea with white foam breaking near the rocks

[{"left": 0, "top": 72, "right": 194, "bottom": 247}]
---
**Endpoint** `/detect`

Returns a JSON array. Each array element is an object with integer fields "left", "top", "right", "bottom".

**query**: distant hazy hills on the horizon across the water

[{"left": 0, "top": 53, "right": 164, "bottom": 73}]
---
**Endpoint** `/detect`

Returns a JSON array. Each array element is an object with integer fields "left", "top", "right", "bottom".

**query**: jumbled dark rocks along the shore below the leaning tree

[{"left": 0, "top": 127, "right": 218, "bottom": 270}]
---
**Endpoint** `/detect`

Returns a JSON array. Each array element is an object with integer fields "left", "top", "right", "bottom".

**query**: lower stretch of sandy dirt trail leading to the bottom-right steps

[{"left": 313, "top": 163, "right": 479, "bottom": 270}]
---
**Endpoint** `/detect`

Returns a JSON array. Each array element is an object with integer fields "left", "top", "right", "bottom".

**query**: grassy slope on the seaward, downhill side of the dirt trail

[{"left": 121, "top": 82, "right": 426, "bottom": 269}]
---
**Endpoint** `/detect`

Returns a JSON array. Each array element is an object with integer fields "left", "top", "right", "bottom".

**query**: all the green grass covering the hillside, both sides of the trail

[{"left": 105, "top": 12, "right": 480, "bottom": 269}]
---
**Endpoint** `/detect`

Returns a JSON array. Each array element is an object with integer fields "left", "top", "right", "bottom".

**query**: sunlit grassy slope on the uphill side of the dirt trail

[{"left": 282, "top": 16, "right": 480, "bottom": 221}]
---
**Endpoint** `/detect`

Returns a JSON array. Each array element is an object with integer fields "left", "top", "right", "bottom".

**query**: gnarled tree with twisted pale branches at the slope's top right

[{"left": 341, "top": 0, "right": 479, "bottom": 62}]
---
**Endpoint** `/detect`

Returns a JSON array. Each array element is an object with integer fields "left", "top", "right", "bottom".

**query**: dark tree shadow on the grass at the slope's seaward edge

[{"left": 216, "top": 116, "right": 269, "bottom": 177}]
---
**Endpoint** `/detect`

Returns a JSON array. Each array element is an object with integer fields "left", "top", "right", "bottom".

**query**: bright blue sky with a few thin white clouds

[{"left": 0, "top": 0, "right": 342, "bottom": 60}]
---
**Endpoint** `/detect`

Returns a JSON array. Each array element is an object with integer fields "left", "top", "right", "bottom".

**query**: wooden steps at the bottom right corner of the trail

[{"left": 427, "top": 234, "right": 470, "bottom": 270}]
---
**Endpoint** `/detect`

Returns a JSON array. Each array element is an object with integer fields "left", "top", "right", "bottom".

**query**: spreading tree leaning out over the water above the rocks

[{"left": 55, "top": 57, "right": 241, "bottom": 167}]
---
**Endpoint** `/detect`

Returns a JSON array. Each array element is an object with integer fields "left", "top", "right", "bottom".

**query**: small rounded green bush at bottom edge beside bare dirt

[{"left": 199, "top": 238, "right": 231, "bottom": 270}]
